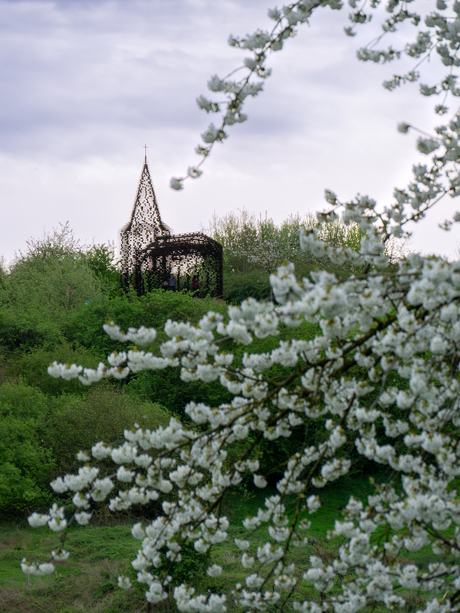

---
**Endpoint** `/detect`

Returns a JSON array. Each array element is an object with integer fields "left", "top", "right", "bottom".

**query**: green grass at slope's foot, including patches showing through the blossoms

[{"left": 0, "top": 476, "right": 450, "bottom": 613}]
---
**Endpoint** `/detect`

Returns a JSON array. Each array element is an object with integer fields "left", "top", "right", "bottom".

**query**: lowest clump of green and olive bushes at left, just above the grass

[{"left": 0, "top": 377, "right": 170, "bottom": 513}]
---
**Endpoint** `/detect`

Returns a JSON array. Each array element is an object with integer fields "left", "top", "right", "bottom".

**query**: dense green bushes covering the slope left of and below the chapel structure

[{"left": 0, "top": 225, "right": 232, "bottom": 516}]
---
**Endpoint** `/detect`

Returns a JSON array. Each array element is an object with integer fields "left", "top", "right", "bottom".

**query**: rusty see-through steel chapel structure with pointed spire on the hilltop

[{"left": 120, "top": 158, "right": 223, "bottom": 297}]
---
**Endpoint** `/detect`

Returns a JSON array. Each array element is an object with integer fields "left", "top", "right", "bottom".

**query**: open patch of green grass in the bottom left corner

[{"left": 0, "top": 523, "right": 150, "bottom": 613}]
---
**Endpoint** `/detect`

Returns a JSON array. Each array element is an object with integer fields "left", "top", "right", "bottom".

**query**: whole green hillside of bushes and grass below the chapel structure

[{"left": 0, "top": 227, "right": 414, "bottom": 613}]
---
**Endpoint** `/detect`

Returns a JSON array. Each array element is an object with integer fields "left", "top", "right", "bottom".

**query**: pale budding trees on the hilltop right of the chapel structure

[{"left": 205, "top": 209, "right": 408, "bottom": 304}]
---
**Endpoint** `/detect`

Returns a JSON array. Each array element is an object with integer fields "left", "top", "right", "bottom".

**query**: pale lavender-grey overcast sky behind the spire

[{"left": 0, "top": 0, "right": 460, "bottom": 260}]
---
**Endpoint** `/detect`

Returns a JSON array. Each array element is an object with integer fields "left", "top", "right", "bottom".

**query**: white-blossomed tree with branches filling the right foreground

[{"left": 22, "top": 0, "right": 460, "bottom": 613}]
